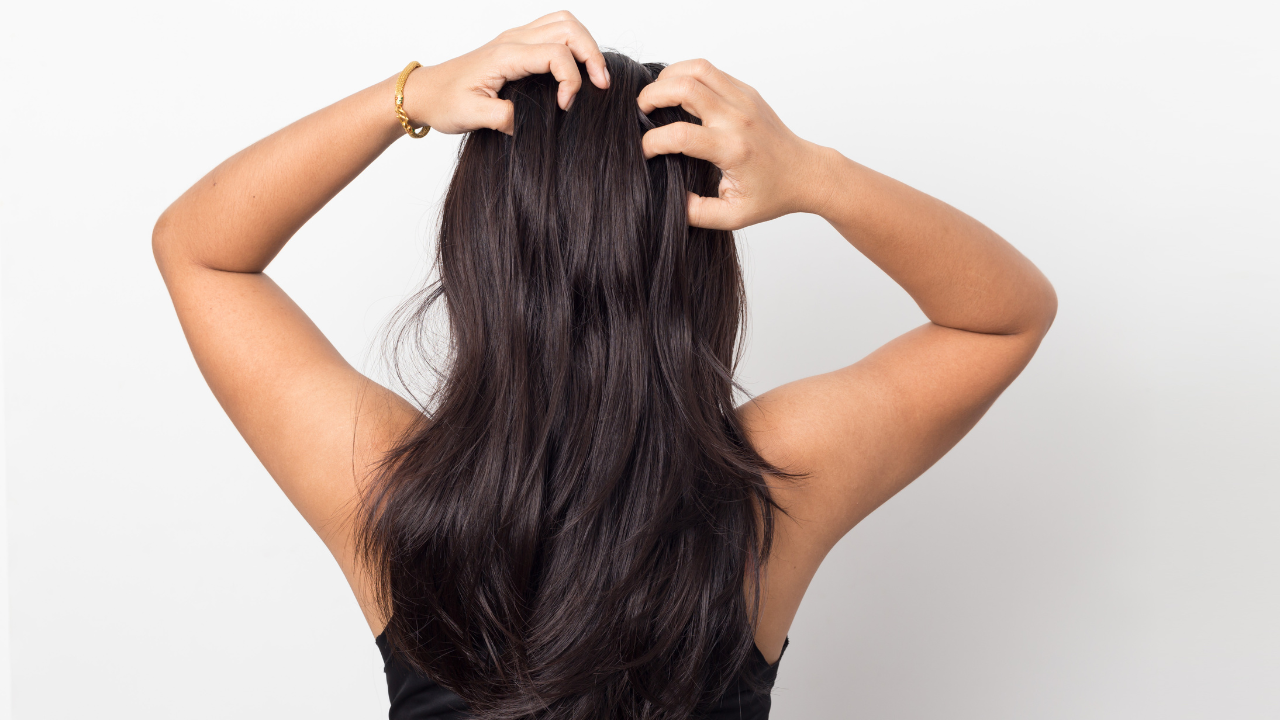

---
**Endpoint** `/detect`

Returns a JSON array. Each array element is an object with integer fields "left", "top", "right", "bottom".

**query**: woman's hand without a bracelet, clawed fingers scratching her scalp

[{"left": 637, "top": 60, "right": 835, "bottom": 231}]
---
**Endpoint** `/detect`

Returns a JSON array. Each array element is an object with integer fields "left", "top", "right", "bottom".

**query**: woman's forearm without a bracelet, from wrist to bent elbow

[{"left": 812, "top": 149, "right": 1057, "bottom": 334}]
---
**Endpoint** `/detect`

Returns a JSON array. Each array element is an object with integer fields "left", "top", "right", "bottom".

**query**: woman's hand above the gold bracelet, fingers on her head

[{"left": 404, "top": 10, "right": 609, "bottom": 135}]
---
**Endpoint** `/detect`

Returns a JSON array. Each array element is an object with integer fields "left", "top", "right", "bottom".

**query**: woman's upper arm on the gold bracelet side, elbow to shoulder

[{"left": 154, "top": 228, "right": 420, "bottom": 561}]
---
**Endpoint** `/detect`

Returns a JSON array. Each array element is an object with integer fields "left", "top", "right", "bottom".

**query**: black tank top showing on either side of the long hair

[{"left": 376, "top": 633, "right": 791, "bottom": 720}]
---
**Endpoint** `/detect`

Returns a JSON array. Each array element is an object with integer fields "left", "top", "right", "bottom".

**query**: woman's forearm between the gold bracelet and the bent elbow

[{"left": 152, "top": 77, "right": 404, "bottom": 273}]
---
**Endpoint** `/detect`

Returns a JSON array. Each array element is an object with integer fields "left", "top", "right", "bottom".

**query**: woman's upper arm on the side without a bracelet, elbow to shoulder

[{"left": 741, "top": 317, "right": 1047, "bottom": 548}]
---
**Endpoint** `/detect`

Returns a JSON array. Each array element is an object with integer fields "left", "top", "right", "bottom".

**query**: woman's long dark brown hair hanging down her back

[{"left": 358, "top": 53, "right": 782, "bottom": 720}]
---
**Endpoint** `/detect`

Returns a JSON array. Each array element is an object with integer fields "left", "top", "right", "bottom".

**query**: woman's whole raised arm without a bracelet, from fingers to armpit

[{"left": 639, "top": 60, "right": 1057, "bottom": 651}]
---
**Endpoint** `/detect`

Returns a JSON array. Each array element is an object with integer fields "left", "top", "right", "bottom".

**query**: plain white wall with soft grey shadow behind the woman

[{"left": 0, "top": 0, "right": 1280, "bottom": 720}]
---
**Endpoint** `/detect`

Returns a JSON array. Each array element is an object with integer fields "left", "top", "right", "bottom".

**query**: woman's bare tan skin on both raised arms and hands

[{"left": 152, "top": 12, "right": 1057, "bottom": 661}]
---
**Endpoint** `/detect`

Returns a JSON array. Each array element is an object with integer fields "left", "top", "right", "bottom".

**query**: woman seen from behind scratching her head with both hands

[{"left": 154, "top": 13, "right": 1056, "bottom": 720}]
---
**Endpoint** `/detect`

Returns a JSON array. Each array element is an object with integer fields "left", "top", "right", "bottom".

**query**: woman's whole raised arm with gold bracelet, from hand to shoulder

[{"left": 152, "top": 13, "right": 608, "bottom": 620}]
